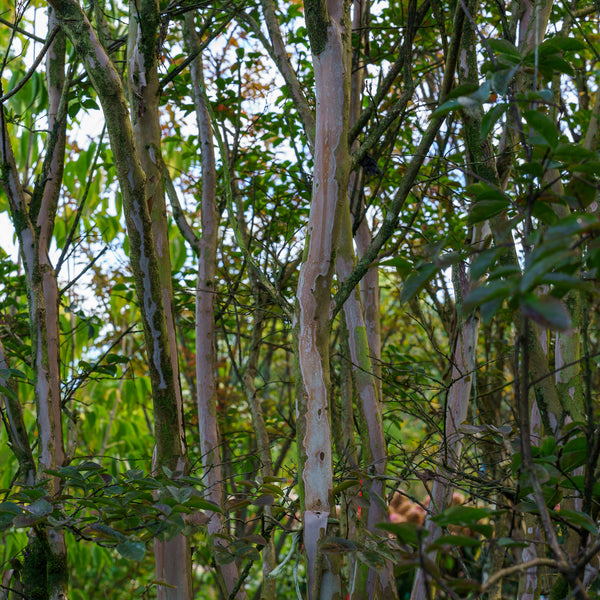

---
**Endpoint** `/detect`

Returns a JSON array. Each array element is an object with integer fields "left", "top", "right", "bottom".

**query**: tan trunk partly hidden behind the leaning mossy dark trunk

[{"left": 127, "top": 0, "right": 192, "bottom": 600}]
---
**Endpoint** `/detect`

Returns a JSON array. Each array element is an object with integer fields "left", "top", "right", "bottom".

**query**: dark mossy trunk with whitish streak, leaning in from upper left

[{"left": 47, "top": 0, "right": 184, "bottom": 470}]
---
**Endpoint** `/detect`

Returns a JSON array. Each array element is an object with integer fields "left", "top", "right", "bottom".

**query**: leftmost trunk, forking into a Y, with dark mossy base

[{"left": 0, "top": 8, "right": 68, "bottom": 600}]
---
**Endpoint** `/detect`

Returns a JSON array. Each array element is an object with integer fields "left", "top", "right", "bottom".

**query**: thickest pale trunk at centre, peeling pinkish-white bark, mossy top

[{"left": 296, "top": 0, "right": 350, "bottom": 600}]
